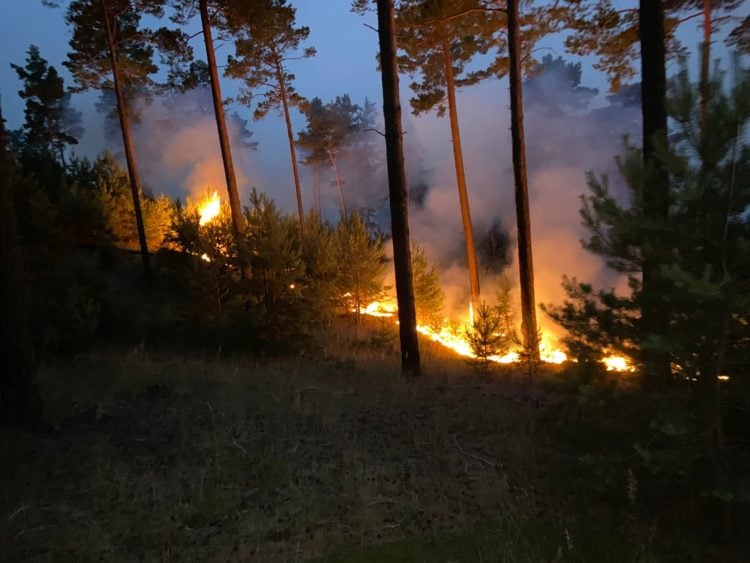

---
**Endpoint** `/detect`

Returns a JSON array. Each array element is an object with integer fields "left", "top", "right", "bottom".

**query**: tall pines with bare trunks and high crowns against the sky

[{"left": 1, "top": 0, "right": 747, "bottom": 416}]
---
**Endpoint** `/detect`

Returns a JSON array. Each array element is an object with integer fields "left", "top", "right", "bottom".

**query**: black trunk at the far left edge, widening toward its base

[{"left": 0, "top": 102, "right": 41, "bottom": 429}]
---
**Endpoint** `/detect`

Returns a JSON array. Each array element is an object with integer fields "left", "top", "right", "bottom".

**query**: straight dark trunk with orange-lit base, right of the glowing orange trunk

[{"left": 508, "top": 0, "right": 539, "bottom": 362}]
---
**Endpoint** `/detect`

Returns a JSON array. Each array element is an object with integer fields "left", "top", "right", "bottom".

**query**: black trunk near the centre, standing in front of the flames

[{"left": 378, "top": 0, "right": 422, "bottom": 376}]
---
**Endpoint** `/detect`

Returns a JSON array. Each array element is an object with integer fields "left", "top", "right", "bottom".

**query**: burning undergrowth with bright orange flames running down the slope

[{"left": 182, "top": 190, "right": 632, "bottom": 370}]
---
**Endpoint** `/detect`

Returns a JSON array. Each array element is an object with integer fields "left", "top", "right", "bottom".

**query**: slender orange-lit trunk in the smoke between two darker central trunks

[{"left": 442, "top": 36, "right": 480, "bottom": 318}]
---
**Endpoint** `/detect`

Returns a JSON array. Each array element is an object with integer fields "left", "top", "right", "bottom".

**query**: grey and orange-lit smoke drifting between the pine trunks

[{"left": 64, "top": 57, "right": 640, "bottom": 331}]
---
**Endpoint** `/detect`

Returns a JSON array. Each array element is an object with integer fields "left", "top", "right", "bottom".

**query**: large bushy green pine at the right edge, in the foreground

[{"left": 547, "top": 64, "right": 750, "bottom": 537}]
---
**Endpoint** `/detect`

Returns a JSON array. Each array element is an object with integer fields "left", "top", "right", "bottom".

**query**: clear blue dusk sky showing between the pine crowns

[{"left": 0, "top": 0, "right": 722, "bottom": 138}]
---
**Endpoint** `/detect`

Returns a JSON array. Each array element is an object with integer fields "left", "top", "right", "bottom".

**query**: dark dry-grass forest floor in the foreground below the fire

[{"left": 0, "top": 328, "right": 736, "bottom": 562}]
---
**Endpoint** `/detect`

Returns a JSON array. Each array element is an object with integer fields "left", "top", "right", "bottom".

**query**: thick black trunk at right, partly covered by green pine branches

[{"left": 639, "top": 0, "right": 670, "bottom": 388}]
